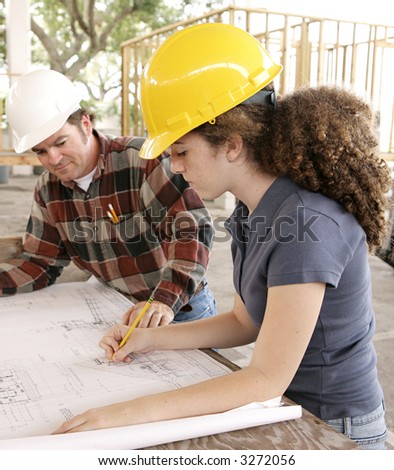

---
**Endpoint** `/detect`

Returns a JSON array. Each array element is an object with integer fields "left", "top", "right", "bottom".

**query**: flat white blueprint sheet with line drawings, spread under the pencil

[{"left": 0, "top": 281, "right": 229, "bottom": 439}]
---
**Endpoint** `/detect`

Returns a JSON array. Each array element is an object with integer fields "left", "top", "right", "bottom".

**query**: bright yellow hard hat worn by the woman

[{"left": 139, "top": 23, "right": 282, "bottom": 159}]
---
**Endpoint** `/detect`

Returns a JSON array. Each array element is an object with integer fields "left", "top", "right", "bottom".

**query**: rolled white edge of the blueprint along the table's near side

[{"left": 0, "top": 397, "right": 302, "bottom": 450}]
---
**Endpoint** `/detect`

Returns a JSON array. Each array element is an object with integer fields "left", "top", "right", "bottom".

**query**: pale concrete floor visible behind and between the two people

[{"left": 0, "top": 175, "right": 394, "bottom": 449}]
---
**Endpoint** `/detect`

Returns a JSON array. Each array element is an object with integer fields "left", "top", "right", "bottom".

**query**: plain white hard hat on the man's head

[{"left": 6, "top": 70, "right": 82, "bottom": 153}]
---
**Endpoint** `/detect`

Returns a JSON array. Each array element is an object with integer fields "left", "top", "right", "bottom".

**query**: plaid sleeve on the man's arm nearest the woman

[{"left": 141, "top": 158, "right": 213, "bottom": 313}]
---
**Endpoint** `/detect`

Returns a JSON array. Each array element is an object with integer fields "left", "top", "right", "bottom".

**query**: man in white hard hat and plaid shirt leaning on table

[{"left": 0, "top": 70, "right": 216, "bottom": 327}]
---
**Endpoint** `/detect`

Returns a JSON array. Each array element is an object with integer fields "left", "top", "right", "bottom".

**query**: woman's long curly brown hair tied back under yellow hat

[{"left": 195, "top": 86, "right": 391, "bottom": 249}]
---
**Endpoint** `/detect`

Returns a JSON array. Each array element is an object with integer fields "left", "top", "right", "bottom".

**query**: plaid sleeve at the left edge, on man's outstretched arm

[{"left": 0, "top": 187, "right": 70, "bottom": 296}]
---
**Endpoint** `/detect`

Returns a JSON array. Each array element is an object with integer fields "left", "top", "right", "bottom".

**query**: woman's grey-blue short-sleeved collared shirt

[{"left": 226, "top": 177, "right": 383, "bottom": 419}]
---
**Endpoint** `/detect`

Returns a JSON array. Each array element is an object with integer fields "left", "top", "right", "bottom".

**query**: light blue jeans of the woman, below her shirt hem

[{"left": 326, "top": 402, "right": 387, "bottom": 450}]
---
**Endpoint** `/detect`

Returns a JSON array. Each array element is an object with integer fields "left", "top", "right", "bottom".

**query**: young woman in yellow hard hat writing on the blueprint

[{"left": 57, "top": 24, "right": 390, "bottom": 449}]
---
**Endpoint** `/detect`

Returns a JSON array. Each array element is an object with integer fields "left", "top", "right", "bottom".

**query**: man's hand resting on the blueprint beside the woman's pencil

[{"left": 122, "top": 300, "right": 174, "bottom": 328}]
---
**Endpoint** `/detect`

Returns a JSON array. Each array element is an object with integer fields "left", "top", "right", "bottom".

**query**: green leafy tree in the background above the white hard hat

[{"left": 28, "top": 0, "right": 221, "bottom": 118}]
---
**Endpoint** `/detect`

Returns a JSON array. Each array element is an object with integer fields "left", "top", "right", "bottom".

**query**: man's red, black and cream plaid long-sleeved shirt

[{"left": 0, "top": 131, "right": 213, "bottom": 312}]
